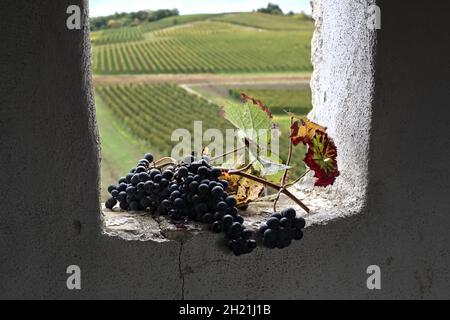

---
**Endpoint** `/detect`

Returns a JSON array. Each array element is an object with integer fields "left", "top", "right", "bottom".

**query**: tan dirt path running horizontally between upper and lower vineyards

[{"left": 94, "top": 74, "right": 311, "bottom": 85}]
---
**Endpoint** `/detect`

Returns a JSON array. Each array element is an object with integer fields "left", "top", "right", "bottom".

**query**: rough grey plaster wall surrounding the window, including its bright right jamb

[{"left": 0, "top": 0, "right": 450, "bottom": 299}]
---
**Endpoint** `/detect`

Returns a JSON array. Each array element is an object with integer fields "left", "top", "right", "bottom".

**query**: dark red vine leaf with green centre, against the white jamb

[{"left": 305, "top": 131, "right": 340, "bottom": 187}]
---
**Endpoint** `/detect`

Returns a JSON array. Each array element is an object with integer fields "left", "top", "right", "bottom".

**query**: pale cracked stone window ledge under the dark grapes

[{"left": 102, "top": 176, "right": 363, "bottom": 243}]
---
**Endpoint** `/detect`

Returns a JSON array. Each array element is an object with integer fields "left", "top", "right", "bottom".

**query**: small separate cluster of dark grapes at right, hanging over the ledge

[{"left": 259, "top": 208, "right": 306, "bottom": 249}]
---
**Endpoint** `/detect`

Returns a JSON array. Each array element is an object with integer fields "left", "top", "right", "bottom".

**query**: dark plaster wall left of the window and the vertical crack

[{"left": 0, "top": 0, "right": 185, "bottom": 299}]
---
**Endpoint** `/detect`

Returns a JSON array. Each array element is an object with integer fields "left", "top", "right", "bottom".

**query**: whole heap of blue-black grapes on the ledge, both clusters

[{"left": 105, "top": 154, "right": 305, "bottom": 256}]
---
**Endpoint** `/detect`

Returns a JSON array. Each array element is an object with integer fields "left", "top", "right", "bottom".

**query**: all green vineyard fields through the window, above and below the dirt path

[{"left": 91, "top": 13, "right": 314, "bottom": 197}]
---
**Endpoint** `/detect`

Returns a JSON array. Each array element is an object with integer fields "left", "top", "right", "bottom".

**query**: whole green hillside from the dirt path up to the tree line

[{"left": 92, "top": 13, "right": 313, "bottom": 74}]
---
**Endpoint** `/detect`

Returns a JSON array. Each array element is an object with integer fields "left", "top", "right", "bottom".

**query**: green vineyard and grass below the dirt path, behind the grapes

[{"left": 96, "top": 83, "right": 309, "bottom": 198}]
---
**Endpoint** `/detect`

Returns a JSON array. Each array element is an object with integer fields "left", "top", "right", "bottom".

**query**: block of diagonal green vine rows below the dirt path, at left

[{"left": 96, "top": 84, "right": 234, "bottom": 155}]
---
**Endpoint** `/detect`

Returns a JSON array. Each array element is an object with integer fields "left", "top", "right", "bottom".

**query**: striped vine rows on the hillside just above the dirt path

[{"left": 94, "top": 22, "right": 312, "bottom": 74}]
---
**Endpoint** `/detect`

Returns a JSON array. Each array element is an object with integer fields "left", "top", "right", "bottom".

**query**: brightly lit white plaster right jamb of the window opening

[{"left": 309, "top": 0, "right": 376, "bottom": 208}]
